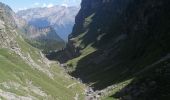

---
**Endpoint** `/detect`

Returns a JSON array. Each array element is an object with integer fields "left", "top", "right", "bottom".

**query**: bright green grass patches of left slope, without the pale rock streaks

[{"left": 0, "top": 37, "right": 84, "bottom": 100}]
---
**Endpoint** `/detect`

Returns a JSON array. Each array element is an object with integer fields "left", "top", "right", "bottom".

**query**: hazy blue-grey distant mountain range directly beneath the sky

[{"left": 17, "top": 5, "right": 79, "bottom": 41}]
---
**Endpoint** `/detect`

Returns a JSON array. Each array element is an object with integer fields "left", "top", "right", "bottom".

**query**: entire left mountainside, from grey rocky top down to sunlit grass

[{"left": 0, "top": 3, "right": 84, "bottom": 100}]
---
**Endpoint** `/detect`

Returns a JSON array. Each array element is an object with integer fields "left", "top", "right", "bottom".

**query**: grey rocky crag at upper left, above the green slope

[{"left": 0, "top": 3, "right": 17, "bottom": 48}]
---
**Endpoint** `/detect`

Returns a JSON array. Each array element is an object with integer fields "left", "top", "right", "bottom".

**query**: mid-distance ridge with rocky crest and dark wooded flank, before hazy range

[{"left": 22, "top": 25, "right": 65, "bottom": 53}]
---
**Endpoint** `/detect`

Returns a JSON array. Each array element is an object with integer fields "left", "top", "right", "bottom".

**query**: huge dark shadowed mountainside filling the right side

[{"left": 57, "top": 0, "right": 170, "bottom": 100}]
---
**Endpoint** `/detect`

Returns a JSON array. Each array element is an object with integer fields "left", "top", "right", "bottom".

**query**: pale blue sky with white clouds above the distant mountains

[{"left": 0, "top": 0, "right": 81, "bottom": 12}]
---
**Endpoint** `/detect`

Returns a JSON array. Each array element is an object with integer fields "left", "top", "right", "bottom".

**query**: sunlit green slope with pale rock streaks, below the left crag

[{"left": 0, "top": 35, "right": 83, "bottom": 100}]
